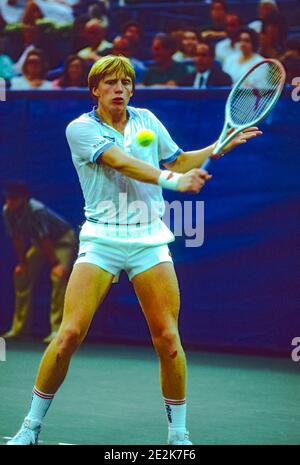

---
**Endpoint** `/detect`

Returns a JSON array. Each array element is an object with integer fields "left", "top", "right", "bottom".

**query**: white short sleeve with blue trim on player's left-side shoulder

[{"left": 66, "top": 121, "right": 113, "bottom": 164}]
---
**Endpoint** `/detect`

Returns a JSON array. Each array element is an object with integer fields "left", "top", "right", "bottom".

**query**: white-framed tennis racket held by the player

[{"left": 201, "top": 59, "right": 286, "bottom": 169}]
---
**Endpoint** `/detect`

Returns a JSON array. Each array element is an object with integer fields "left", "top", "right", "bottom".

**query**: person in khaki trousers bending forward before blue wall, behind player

[{"left": 3, "top": 181, "right": 77, "bottom": 343}]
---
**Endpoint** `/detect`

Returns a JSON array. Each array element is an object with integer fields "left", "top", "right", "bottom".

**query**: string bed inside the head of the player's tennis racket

[{"left": 230, "top": 63, "right": 283, "bottom": 125}]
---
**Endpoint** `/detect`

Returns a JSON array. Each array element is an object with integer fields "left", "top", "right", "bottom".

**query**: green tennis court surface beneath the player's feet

[{"left": 0, "top": 341, "right": 300, "bottom": 445}]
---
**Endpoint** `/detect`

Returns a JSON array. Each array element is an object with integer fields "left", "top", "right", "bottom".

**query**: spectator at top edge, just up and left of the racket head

[{"left": 200, "top": 0, "right": 227, "bottom": 41}]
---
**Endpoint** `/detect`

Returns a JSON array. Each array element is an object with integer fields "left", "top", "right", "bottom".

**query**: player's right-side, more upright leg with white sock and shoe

[{"left": 132, "top": 262, "right": 191, "bottom": 444}]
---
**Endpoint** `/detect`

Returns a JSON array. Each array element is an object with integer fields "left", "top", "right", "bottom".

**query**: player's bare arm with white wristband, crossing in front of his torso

[{"left": 97, "top": 145, "right": 211, "bottom": 193}]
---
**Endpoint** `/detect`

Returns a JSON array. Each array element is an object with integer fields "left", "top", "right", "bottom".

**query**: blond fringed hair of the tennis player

[{"left": 88, "top": 55, "right": 135, "bottom": 92}]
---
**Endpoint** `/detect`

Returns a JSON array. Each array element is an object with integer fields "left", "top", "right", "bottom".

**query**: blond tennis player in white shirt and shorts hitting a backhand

[{"left": 8, "top": 56, "right": 260, "bottom": 445}]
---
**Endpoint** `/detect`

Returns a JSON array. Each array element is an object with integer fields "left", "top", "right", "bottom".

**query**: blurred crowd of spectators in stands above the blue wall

[{"left": 0, "top": 0, "right": 300, "bottom": 90}]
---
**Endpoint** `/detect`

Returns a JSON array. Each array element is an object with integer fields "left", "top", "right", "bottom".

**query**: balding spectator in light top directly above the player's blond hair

[{"left": 78, "top": 19, "right": 112, "bottom": 63}]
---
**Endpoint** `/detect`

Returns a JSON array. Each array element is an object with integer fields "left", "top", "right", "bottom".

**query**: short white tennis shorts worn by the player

[{"left": 75, "top": 222, "right": 173, "bottom": 281}]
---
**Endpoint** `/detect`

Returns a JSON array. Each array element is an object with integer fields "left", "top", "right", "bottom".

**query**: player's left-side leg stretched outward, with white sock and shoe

[{"left": 8, "top": 263, "right": 113, "bottom": 445}]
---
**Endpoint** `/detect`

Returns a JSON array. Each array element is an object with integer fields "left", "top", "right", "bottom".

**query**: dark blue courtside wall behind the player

[{"left": 0, "top": 89, "right": 300, "bottom": 354}]
